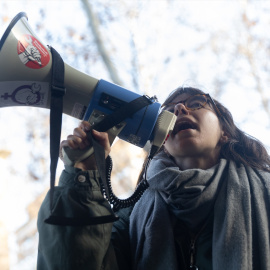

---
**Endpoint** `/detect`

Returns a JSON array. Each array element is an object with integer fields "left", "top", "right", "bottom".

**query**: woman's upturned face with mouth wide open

[{"left": 164, "top": 94, "right": 224, "bottom": 159}]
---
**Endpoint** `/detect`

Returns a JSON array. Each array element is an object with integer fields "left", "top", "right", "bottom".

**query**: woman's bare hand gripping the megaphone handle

[{"left": 60, "top": 121, "right": 111, "bottom": 171}]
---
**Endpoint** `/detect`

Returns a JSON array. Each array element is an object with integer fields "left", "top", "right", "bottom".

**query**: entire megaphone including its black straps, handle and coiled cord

[{"left": 0, "top": 12, "right": 176, "bottom": 226}]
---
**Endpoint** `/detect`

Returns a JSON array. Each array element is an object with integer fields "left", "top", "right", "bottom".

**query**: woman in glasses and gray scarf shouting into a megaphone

[{"left": 38, "top": 88, "right": 270, "bottom": 270}]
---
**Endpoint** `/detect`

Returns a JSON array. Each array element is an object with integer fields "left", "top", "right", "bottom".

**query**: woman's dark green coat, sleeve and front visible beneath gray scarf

[{"left": 37, "top": 166, "right": 212, "bottom": 270}]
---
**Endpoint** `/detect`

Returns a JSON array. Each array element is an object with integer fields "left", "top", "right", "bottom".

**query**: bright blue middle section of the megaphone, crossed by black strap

[{"left": 84, "top": 80, "right": 161, "bottom": 147}]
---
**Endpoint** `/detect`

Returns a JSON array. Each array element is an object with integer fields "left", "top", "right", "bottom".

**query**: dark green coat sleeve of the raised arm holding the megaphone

[{"left": 37, "top": 167, "right": 118, "bottom": 270}]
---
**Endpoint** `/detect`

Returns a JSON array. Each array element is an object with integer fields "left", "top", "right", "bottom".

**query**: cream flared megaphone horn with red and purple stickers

[{"left": 0, "top": 12, "right": 98, "bottom": 119}]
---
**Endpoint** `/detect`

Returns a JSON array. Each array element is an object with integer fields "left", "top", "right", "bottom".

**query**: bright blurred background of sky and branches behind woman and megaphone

[{"left": 0, "top": 0, "right": 270, "bottom": 270}]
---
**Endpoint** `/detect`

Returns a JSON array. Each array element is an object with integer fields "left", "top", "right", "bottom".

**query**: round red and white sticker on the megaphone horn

[{"left": 17, "top": 34, "right": 50, "bottom": 69}]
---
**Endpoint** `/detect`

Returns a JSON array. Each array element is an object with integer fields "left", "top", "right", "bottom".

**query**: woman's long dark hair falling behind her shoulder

[{"left": 138, "top": 87, "right": 270, "bottom": 182}]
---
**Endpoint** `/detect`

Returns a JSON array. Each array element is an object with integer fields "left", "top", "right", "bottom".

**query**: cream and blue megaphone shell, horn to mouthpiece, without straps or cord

[{"left": 0, "top": 12, "right": 175, "bottom": 160}]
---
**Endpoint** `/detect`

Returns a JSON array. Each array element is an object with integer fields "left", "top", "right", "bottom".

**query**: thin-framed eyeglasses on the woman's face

[{"left": 163, "top": 94, "right": 222, "bottom": 117}]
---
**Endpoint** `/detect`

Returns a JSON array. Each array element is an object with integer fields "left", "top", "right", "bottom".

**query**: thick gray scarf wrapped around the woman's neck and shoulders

[{"left": 130, "top": 152, "right": 270, "bottom": 270}]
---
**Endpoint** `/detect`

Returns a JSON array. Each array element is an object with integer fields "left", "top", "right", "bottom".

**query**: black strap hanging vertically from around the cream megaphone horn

[{"left": 50, "top": 47, "right": 66, "bottom": 215}]
